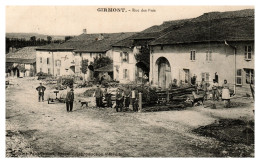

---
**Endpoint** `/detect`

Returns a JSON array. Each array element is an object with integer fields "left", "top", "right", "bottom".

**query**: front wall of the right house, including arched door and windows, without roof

[{"left": 150, "top": 41, "right": 254, "bottom": 88}]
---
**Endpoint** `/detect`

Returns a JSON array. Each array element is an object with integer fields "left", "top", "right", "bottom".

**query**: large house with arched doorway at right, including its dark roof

[{"left": 149, "top": 12, "right": 255, "bottom": 89}]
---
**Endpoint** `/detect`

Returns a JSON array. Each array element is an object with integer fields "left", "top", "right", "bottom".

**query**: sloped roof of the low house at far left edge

[{"left": 6, "top": 46, "right": 37, "bottom": 59}]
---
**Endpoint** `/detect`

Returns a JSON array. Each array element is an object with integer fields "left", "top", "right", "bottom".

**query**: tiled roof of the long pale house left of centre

[{"left": 37, "top": 32, "right": 134, "bottom": 52}]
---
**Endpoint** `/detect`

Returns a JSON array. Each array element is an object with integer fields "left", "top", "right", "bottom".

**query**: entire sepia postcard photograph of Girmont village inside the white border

[{"left": 3, "top": 5, "right": 255, "bottom": 158}]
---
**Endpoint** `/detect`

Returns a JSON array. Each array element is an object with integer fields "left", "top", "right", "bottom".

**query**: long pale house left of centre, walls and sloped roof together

[{"left": 36, "top": 33, "right": 133, "bottom": 80}]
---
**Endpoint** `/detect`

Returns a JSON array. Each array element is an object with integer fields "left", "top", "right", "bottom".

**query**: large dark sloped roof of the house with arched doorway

[{"left": 150, "top": 16, "right": 254, "bottom": 45}]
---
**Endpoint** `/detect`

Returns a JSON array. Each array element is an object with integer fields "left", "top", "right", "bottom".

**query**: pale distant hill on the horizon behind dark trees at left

[{"left": 6, "top": 33, "right": 68, "bottom": 40}]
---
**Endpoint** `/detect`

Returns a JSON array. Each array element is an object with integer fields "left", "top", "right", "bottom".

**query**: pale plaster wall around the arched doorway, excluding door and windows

[{"left": 150, "top": 42, "right": 254, "bottom": 88}]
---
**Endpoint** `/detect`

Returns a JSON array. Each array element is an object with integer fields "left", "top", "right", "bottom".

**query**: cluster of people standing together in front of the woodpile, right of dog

[{"left": 94, "top": 85, "right": 138, "bottom": 112}]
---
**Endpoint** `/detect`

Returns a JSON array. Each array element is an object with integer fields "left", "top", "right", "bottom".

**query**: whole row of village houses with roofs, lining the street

[{"left": 6, "top": 10, "right": 254, "bottom": 91}]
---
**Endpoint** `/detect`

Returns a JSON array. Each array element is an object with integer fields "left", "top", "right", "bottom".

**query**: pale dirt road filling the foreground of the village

[{"left": 6, "top": 78, "right": 254, "bottom": 157}]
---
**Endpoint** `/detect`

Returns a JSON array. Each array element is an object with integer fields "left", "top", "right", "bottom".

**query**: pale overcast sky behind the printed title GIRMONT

[{"left": 6, "top": 6, "right": 254, "bottom": 35}]
